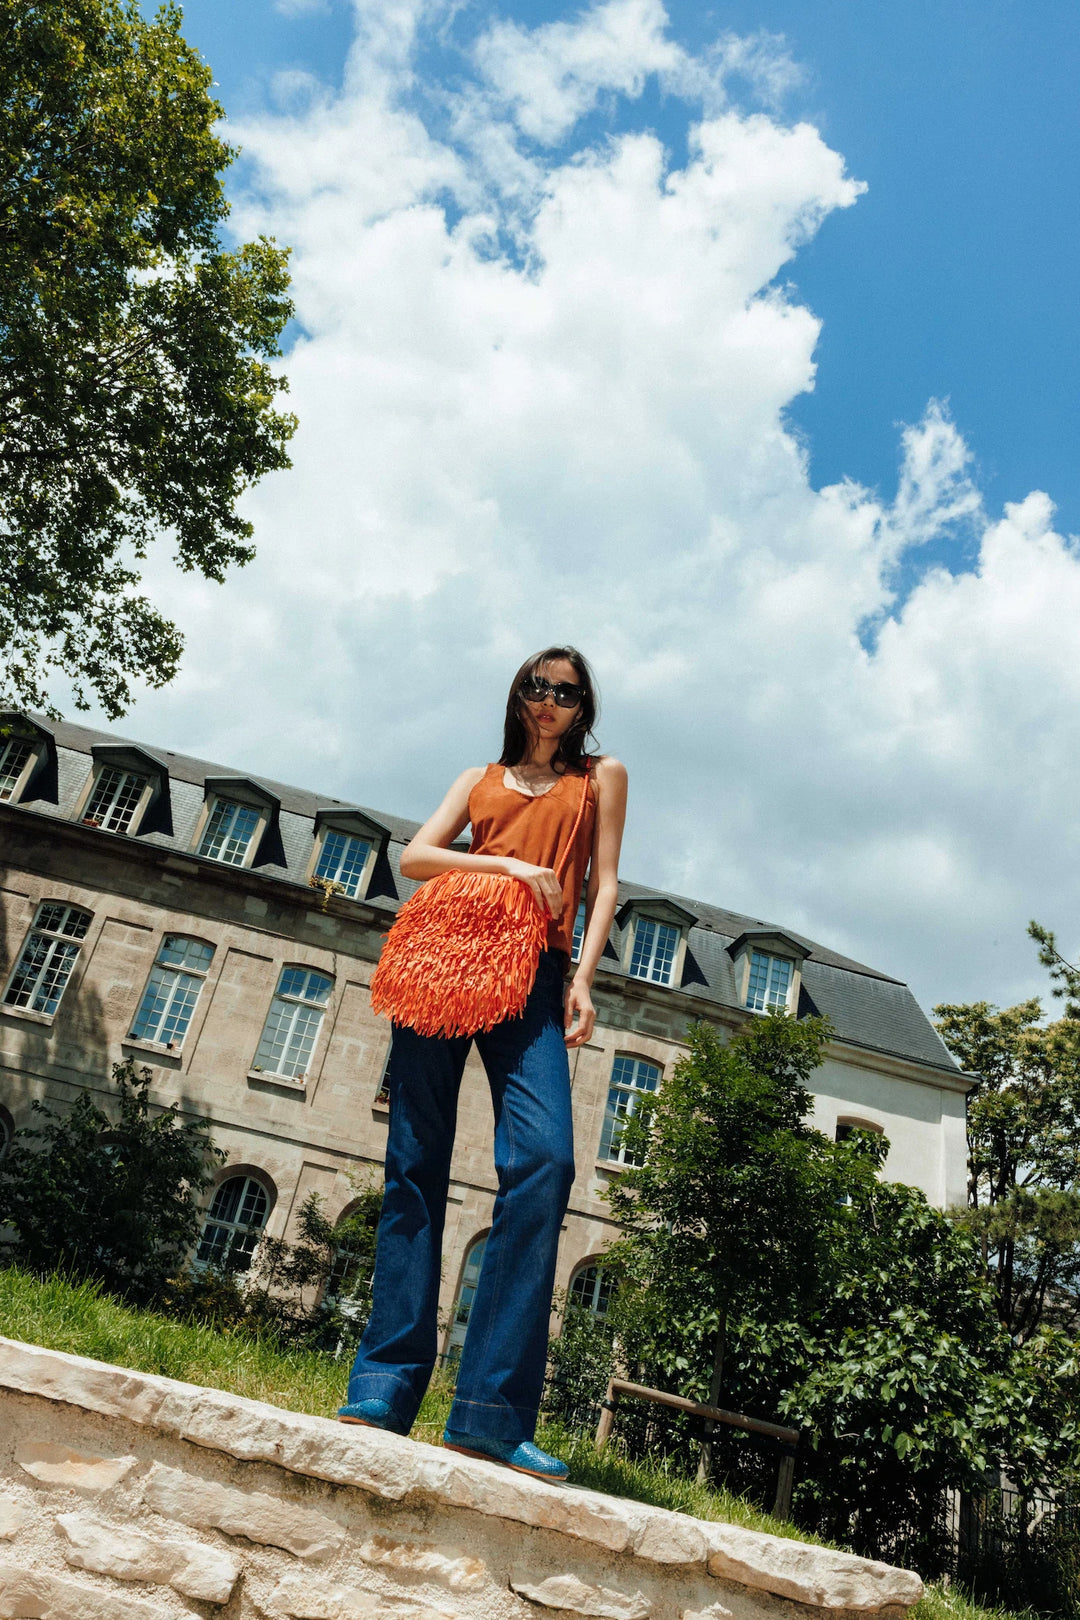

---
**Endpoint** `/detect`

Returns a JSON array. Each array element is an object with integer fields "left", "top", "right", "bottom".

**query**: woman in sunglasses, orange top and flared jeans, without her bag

[{"left": 338, "top": 646, "right": 627, "bottom": 1479}]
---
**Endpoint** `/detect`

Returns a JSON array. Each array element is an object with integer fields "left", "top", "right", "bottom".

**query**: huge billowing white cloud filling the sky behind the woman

[{"left": 103, "top": 0, "right": 1080, "bottom": 1000}]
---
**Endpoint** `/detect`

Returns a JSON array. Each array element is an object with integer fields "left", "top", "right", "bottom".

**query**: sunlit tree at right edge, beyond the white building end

[{"left": 934, "top": 923, "right": 1080, "bottom": 1340}]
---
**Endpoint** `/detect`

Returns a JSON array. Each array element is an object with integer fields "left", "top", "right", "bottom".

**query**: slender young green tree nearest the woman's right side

[{"left": 607, "top": 1014, "right": 842, "bottom": 1405}]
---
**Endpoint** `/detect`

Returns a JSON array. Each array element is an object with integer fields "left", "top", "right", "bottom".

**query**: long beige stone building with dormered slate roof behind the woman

[{"left": 0, "top": 716, "right": 967, "bottom": 1353}]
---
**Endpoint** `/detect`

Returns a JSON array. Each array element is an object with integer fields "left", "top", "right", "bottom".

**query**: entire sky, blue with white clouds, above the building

[{"left": 103, "top": 0, "right": 1080, "bottom": 1004}]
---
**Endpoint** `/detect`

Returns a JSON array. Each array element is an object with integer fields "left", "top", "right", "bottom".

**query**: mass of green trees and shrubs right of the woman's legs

[{"left": 592, "top": 1016, "right": 1077, "bottom": 1571}]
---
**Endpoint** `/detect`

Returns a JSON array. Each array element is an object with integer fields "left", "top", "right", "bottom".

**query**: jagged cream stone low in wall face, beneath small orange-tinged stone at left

[{"left": 57, "top": 1513, "right": 240, "bottom": 1604}]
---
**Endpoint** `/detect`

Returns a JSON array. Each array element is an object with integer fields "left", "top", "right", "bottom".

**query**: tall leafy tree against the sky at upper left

[{"left": 0, "top": 0, "right": 295, "bottom": 718}]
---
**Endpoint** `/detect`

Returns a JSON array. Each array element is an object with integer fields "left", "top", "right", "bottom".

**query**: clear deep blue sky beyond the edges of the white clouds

[{"left": 185, "top": 0, "right": 1080, "bottom": 567}]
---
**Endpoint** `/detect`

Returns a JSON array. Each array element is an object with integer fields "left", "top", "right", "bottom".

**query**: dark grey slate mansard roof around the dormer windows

[{"left": 4, "top": 721, "right": 960, "bottom": 1079}]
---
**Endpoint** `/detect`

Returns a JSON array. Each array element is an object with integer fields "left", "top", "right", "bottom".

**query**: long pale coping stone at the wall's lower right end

[{"left": 706, "top": 1524, "right": 923, "bottom": 1614}]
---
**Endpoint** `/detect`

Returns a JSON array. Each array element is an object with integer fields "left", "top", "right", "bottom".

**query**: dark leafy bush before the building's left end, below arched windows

[{"left": 0, "top": 1059, "right": 225, "bottom": 1304}]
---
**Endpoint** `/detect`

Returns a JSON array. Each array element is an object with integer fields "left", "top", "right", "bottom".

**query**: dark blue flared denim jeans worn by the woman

[{"left": 348, "top": 951, "right": 573, "bottom": 1445}]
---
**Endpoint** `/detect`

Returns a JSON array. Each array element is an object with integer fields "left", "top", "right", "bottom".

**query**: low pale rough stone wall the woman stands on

[{"left": 0, "top": 1340, "right": 921, "bottom": 1620}]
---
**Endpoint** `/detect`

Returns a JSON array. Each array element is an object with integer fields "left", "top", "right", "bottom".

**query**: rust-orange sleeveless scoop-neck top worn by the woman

[{"left": 468, "top": 765, "right": 596, "bottom": 956}]
